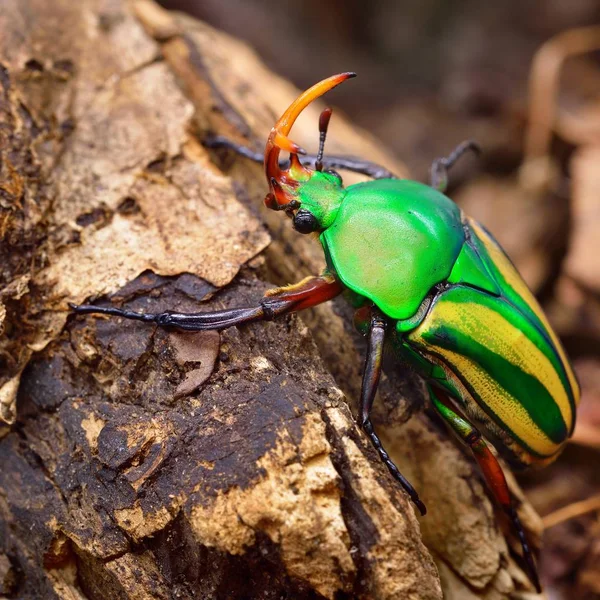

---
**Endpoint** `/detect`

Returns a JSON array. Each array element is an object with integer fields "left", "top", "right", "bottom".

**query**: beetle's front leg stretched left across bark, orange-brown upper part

[{"left": 69, "top": 273, "right": 344, "bottom": 331}]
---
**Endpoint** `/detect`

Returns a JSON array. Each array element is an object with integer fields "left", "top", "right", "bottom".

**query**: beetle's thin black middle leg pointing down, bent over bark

[{"left": 360, "top": 310, "right": 427, "bottom": 515}]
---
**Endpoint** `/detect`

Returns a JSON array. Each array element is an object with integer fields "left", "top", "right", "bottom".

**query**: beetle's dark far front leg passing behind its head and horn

[{"left": 203, "top": 135, "right": 397, "bottom": 179}]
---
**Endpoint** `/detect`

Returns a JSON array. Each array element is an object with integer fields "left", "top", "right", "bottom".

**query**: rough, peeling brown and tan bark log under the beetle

[{"left": 0, "top": 0, "right": 539, "bottom": 600}]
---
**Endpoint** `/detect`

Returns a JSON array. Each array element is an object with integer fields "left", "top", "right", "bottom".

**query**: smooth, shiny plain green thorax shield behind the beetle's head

[{"left": 321, "top": 179, "right": 465, "bottom": 320}]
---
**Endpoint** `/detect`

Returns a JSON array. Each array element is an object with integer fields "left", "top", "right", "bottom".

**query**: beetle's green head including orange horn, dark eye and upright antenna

[{"left": 265, "top": 73, "right": 355, "bottom": 233}]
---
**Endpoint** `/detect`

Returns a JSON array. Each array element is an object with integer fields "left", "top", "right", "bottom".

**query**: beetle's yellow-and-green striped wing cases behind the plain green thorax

[{"left": 405, "top": 221, "right": 578, "bottom": 465}]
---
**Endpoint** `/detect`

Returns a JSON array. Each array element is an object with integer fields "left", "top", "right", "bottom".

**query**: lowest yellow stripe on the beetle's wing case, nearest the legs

[{"left": 409, "top": 328, "right": 560, "bottom": 456}]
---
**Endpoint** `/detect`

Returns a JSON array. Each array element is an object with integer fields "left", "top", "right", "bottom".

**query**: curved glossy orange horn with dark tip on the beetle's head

[{"left": 265, "top": 73, "right": 356, "bottom": 209}]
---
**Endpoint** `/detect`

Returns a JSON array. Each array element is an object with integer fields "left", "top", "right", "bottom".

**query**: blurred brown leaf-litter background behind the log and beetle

[{"left": 161, "top": 0, "right": 600, "bottom": 600}]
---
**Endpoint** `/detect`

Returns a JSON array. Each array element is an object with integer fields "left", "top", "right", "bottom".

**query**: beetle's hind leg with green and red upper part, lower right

[{"left": 428, "top": 386, "right": 542, "bottom": 593}]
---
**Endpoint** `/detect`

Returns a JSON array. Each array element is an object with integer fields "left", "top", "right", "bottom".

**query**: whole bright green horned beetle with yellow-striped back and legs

[{"left": 72, "top": 73, "right": 579, "bottom": 590}]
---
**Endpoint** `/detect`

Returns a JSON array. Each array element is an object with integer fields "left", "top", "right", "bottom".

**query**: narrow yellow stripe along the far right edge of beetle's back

[{"left": 467, "top": 217, "right": 579, "bottom": 410}]
